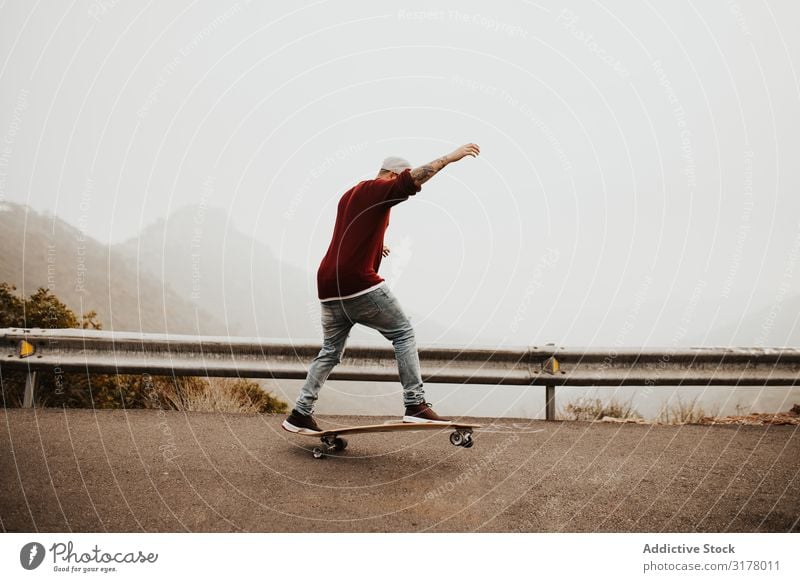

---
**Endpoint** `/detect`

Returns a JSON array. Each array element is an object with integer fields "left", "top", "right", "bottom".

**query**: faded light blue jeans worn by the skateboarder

[{"left": 295, "top": 285, "right": 425, "bottom": 414}]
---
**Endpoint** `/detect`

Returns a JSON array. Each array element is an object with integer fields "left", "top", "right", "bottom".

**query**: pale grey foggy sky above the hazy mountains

[{"left": 0, "top": 0, "right": 800, "bottom": 345}]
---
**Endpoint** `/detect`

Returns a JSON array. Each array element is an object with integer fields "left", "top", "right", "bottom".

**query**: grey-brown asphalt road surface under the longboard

[{"left": 0, "top": 409, "right": 800, "bottom": 532}]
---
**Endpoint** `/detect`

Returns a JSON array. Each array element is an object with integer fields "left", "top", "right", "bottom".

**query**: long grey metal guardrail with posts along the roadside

[{"left": 0, "top": 328, "right": 800, "bottom": 420}]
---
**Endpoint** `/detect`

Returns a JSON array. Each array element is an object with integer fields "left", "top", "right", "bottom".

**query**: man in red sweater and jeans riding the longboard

[{"left": 283, "top": 143, "right": 480, "bottom": 432}]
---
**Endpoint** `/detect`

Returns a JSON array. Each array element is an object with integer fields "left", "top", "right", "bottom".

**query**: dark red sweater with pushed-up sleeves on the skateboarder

[{"left": 317, "top": 170, "right": 420, "bottom": 300}]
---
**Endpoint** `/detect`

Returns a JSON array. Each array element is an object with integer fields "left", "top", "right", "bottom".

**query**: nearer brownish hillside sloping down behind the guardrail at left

[{"left": 0, "top": 202, "right": 224, "bottom": 335}]
